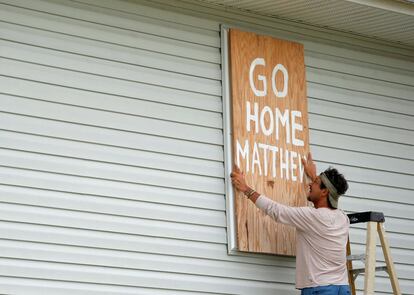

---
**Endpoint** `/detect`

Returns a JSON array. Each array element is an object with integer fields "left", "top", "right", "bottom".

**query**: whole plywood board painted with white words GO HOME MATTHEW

[{"left": 229, "top": 29, "right": 309, "bottom": 256}]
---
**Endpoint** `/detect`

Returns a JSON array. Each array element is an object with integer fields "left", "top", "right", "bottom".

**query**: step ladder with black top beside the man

[{"left": 346, "top": 211, "right": 401, "bottom": 295}]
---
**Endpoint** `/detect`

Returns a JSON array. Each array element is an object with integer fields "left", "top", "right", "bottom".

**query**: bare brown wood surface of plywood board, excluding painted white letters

[{"left": 229, "top": 29, "right": 309, "bottom": 256}]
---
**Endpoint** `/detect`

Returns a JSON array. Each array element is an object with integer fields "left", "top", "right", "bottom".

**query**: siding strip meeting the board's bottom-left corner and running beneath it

[{"left": 0, "top": 221, "right": 295, "bottom": 268}]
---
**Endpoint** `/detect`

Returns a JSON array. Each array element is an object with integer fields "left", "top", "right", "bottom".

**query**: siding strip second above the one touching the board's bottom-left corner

[{"left": 0, "top": 185, "right": 226, "bottom": 227}]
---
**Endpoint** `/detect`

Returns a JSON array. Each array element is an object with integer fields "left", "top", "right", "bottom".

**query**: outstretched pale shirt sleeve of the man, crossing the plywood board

[{"left": 256, "top": 195, "right": 315, "bottom": 231}]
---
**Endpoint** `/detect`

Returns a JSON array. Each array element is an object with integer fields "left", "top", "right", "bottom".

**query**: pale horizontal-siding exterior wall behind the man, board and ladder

[{"left": 0, "top": 0, "right": 414, "bottom": 294}]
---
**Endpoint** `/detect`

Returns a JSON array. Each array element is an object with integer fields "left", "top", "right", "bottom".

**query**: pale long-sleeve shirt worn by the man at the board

[{"left": 256, "top": 195, "right": 349, "bottom": 289}]
